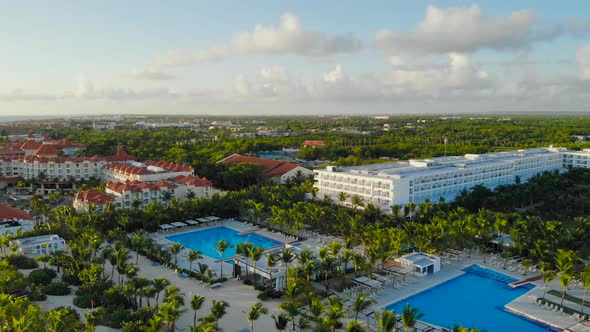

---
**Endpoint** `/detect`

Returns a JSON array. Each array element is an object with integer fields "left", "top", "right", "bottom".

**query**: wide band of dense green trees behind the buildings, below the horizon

[{"left": 50, "top": 117, "right": 590, "bottom": 169}]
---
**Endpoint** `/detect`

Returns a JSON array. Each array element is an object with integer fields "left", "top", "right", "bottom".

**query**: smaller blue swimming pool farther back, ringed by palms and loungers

[{"left": 166, "top": 226, "right": 282, "bottom": 259}]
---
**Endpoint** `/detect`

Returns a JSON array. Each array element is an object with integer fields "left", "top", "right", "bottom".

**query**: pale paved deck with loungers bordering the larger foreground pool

[{"left": 373, "top": 256, "right": 590, "bottom": 330}]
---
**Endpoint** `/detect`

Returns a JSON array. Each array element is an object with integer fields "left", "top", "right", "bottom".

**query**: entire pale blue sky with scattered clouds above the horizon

[{"left": 0, "top": 0, "right": 590, "bottom": 116}]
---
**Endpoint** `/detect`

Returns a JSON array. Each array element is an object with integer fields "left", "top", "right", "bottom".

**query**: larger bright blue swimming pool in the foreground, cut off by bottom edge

[{"left": 387, "top": 265, "right": 552, "bottom": 332}]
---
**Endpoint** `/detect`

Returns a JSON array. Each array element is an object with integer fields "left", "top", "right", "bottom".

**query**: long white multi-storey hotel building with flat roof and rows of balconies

[{"left": 314, "top": 147, "right": 590, "bottom": 211}]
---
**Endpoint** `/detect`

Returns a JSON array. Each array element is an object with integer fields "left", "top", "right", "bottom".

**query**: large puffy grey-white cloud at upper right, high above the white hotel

[{"left": 375, "top": 5, "right": 535, "bottom": 54}]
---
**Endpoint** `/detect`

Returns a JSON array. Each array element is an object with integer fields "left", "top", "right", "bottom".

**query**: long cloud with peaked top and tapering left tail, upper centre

[{"left": 153, "top": 13, "right": 362, "bottom": 66}]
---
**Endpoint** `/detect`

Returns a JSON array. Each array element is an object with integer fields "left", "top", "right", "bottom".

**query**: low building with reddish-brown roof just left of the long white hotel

[{"left": 219, "top": 153, "right": 313, "bottom": 184}]
